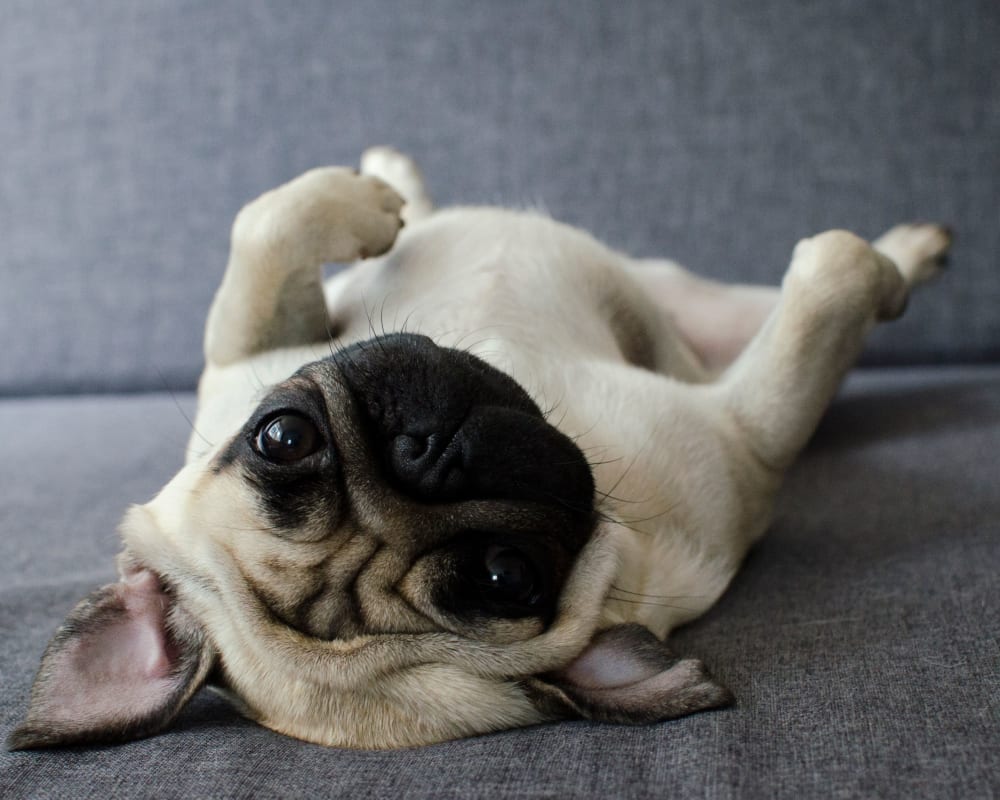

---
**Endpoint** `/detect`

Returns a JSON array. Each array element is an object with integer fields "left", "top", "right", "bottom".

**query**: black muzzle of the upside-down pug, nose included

[{"left": 332, "top": 334, "right": 594, "bottom": 518}]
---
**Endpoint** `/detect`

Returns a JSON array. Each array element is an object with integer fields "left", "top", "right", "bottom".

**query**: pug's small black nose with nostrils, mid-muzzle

[{"left": 389, "top": 430, "right": 468, "bottom": 498}]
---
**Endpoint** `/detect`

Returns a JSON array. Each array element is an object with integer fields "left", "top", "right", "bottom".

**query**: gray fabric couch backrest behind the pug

[{"left": 0, "top": 0, "right": 1000, "bottom": 394}]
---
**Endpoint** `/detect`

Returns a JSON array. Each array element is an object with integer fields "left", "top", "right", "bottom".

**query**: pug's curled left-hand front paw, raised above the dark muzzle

[{"left": 233, "top": 167, "right": 403, "bottom": 264}]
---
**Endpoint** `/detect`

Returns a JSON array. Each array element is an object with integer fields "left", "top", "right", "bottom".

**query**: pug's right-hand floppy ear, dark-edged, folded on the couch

[{"left": 529, "top": 624, "right": 734, "bottom": 725}]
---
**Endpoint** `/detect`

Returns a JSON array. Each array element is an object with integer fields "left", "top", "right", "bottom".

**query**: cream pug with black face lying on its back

[{"left": 9, "top": 148, "right": 949, "bottom": 748}]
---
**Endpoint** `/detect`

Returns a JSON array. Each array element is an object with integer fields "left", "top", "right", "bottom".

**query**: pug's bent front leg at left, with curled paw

[{"left": 205, "top": 167, "right": 403, "bottom": 367}]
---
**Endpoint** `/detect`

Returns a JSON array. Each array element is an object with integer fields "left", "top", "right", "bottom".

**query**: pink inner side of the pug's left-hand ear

[{"left": 45, "top": 570, "right": 185, "bottom": 727}]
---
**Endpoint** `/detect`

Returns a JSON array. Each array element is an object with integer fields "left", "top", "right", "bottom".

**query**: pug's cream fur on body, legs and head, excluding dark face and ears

[{"left": 113, "top": 148, "right": 948, "bottom": 747}]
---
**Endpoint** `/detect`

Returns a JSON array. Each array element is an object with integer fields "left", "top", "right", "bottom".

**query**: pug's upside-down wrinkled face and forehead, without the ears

[{"left": 135, "top": 335, "right": 611, "bottom": 746}]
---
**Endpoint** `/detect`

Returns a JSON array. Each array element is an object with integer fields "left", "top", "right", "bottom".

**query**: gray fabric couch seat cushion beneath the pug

[{"left": 0, "top": 367, "right": 1000, "bottom": 800}]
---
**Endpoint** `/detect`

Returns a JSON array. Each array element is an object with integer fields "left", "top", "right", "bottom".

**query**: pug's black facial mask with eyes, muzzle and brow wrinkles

[{"left": 200, "top": 335, "right": 594, "bottom": 642}]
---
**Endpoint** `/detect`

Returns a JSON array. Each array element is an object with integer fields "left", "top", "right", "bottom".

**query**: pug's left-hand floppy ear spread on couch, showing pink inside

[{"left": 7, "top": 570, "right": 212, "bottom": 750}]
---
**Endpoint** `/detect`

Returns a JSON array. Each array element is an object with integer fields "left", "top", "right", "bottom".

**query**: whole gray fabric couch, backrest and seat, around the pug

[{"left": 0, "top": 0, "right": 1000, "bottom": 800}]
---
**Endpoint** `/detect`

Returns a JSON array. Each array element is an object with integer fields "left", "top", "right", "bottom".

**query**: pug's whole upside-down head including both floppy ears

[{"left": 10, "top": 335, "right": 729, "bottom": 748}]
